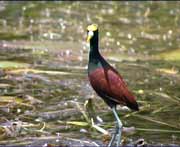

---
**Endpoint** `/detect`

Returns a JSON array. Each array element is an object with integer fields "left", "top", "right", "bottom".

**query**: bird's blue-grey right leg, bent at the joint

[{"left": 112, "top": 107, "right": 122, "bottom": 147}]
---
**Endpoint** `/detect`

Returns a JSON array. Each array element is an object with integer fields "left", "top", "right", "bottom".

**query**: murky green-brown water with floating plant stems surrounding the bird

[{"left": 0, "top": 1, "right": 180, "bottom": 146}]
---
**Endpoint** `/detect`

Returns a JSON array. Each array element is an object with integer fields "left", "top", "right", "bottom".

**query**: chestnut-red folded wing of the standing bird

[{"left": 89, "top": 68, "right": 135, "bottom": 104}]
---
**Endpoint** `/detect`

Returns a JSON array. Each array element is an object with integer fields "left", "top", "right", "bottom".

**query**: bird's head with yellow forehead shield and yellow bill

[{"left": 87, "top": 24, "right": 98, "bottom": 42}]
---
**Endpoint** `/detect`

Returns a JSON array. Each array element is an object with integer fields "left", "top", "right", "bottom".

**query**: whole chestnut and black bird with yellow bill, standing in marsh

[{"left": 87, "top": 24, "right": 139, "bottom": 147}]
